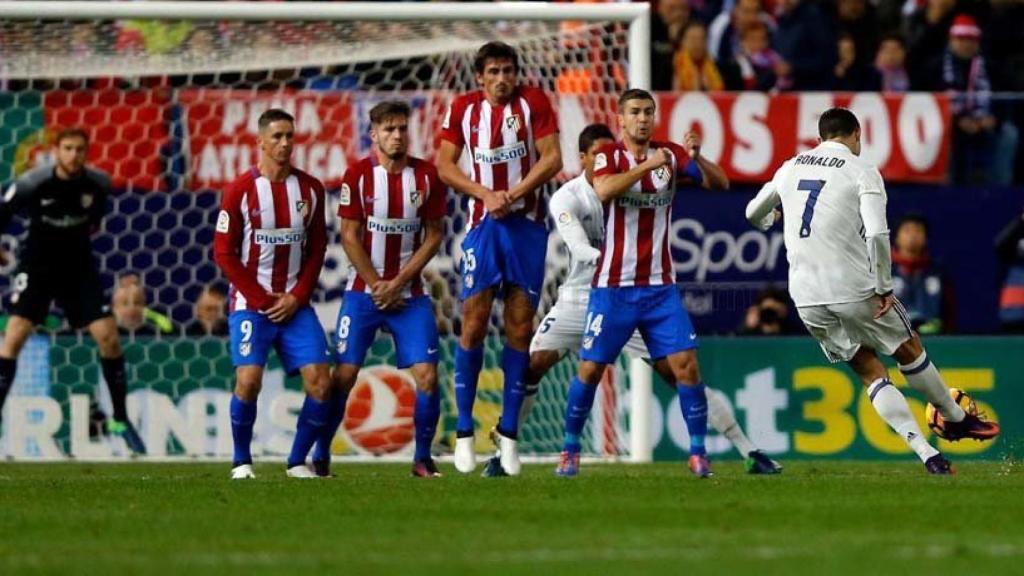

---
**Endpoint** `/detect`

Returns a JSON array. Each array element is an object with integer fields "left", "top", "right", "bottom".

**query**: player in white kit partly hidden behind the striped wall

[{"left": 483, "top": 124, "right": 782, "bottom": 474}]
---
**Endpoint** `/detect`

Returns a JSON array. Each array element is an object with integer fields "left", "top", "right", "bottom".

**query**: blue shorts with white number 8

[{"left": 334, "top": 291, "right": 439, "bottom": 368}]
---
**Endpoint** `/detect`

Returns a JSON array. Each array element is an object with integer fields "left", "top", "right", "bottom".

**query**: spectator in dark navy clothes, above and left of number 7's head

[{"left": 775, "top": 0, "right": 837, "bottom": 90}]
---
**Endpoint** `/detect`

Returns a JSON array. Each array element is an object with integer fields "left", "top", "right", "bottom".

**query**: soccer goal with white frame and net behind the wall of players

[{"left": 0, "top": 1, "right": 651, "bottom": 461}]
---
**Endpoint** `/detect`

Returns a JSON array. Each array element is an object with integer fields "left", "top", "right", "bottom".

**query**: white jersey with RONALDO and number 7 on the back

[{"left": 746, "top": 141, "right": 892, "bottom": 307}]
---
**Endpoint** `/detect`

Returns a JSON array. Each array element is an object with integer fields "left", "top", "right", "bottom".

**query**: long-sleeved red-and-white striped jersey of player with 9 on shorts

[{"left": 213, "top": 168, "right": 327, "bottom": 312}]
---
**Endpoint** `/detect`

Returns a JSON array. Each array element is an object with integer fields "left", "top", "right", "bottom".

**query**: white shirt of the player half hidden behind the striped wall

[{"left": 548, "top": 173, "right": 604, "bottom": 304}]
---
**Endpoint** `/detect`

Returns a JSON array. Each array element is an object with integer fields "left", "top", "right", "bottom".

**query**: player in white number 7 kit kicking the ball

[{"left": 746, "top": 108, "right": 999, "bottom": 475}]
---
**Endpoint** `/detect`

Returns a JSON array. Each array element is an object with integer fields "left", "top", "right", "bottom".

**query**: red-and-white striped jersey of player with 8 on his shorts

[{"left": 338, "top": 155, "right": 447, "bottom": 297}]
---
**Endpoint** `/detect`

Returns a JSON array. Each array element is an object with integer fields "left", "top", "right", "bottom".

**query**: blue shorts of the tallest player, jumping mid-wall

[{"left": 462, "top": 215, "right": 548, "bottom": 308}]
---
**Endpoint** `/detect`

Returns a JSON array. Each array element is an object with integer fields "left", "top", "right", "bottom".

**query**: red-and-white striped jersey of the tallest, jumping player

[{"left": 441, "top": 86, "right": 558, "bottom": 230}]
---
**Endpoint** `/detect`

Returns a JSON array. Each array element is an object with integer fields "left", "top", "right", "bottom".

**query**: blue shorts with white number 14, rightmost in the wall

[{"left": 580, "top": 285, "right": 697, "bottom": 364}]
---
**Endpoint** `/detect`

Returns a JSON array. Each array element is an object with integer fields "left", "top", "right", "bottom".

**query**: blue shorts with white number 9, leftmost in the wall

[{"left": 227, "top": 306, "right": 331, "bottom": 374}]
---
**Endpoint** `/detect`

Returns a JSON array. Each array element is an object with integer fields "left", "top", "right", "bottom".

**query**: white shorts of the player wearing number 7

[{"left": 797, "top": 297, "right": 913, "bottom": 364}]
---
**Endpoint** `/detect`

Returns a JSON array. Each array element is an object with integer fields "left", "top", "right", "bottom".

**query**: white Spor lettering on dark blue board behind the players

[{"left": 670, "top": 218, "right": 784, "bottom": 282}]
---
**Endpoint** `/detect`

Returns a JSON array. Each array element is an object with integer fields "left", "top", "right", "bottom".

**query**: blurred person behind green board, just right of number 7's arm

[{"left": 893, "top": 215, "right": 951, "bottom": 334}]
